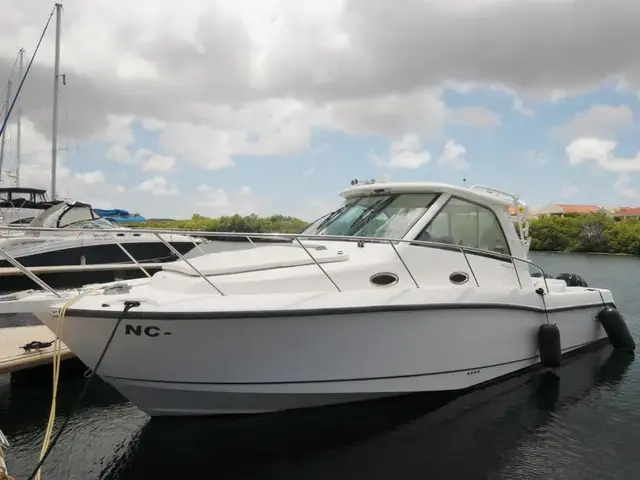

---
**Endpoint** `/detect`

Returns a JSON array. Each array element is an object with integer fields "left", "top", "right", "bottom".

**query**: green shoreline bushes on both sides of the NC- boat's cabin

[{"left": 132, "top": 213, "right": 640, "bottom": 255}]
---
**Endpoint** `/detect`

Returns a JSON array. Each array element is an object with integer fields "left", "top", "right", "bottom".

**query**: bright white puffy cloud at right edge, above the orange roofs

[{"left": 566, "top": 138, "right": 640, "bottom": 173}]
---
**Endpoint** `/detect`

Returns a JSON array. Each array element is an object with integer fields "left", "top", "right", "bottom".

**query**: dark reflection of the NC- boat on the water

[{"left": 100, "top": 347, "right": 633, "bottom": 479}]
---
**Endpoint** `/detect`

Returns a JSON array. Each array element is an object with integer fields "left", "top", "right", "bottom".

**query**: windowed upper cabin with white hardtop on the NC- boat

[{"left": 303, "top": 182, "right": 528, "bottom": 258}]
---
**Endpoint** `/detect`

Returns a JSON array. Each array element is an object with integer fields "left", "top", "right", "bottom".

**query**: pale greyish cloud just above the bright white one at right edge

[{"left": 553, "top": 105, "right": 634, "bottom": 142}]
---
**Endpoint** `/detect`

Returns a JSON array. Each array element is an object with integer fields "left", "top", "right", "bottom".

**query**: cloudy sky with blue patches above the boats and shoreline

[{"left": 0, "top": 0, "right": 640, "bottom": 220}]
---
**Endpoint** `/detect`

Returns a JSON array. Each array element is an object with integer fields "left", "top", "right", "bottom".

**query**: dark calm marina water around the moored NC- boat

[{"left": 0, "top": 253, "right": 640, "bottom": 480}]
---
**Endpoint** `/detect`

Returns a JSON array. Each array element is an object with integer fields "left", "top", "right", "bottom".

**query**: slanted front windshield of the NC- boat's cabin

[{"left": 303, "top": 193, "right": 438, "bottom": 238}]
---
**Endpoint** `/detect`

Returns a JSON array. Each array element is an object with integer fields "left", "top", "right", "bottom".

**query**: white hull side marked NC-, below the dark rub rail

[{"left": 38, "top": 304, "right": 606, "bottom": 416}]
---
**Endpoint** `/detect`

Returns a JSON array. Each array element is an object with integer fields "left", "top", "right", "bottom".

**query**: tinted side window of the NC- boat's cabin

[{"left": 417, "top": 198, "right": 509, "bottom": 254}]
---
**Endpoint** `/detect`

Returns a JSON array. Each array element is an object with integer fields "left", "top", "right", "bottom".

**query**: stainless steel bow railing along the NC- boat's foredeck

[{"left": 0, "top": 226, "right": 549, "bottom": 296}]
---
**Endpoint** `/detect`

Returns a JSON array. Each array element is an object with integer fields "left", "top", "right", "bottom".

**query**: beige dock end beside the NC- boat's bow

[{"left": 0, "top": 325, "right": 75, "bottom": 375}]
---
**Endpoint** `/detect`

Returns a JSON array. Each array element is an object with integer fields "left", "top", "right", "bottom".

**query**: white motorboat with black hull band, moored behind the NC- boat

[{"left": 0, "top": 200, "right": 203, "bottom": 292}]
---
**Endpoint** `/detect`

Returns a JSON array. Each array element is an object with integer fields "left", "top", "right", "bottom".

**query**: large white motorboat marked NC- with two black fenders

[{"left": 0, "top": 183, "right": 635, "bottom": 416}]
